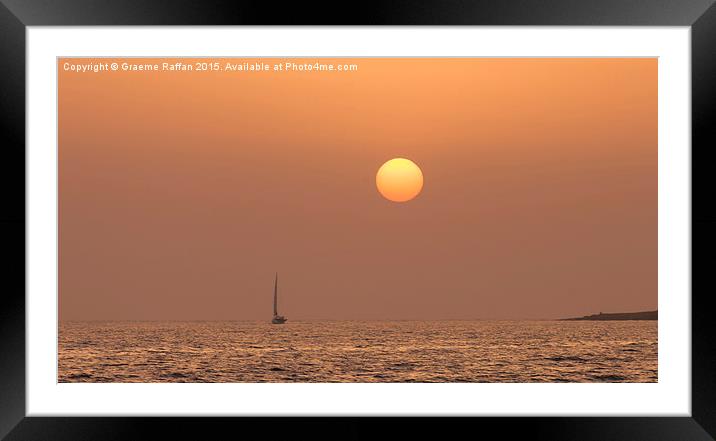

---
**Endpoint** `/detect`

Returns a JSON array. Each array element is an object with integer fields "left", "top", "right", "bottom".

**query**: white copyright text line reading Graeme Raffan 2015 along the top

[{"left": 60, "top": 59, "right": 359, "bottom": 74}]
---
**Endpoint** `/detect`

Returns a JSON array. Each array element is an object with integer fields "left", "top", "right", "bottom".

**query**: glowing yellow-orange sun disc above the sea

[{"left": 375, "top": 158, "right": 423, "bottom": 202}]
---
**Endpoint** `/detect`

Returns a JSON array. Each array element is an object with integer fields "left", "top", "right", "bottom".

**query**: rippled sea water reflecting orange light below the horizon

[{"left": 58, "top": 321, "right": 657, "bottom": 383}]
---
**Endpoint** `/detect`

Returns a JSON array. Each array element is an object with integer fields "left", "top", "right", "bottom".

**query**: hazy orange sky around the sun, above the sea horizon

[{"left": 58, "top": 58, "right": 657, "bottom": 320}]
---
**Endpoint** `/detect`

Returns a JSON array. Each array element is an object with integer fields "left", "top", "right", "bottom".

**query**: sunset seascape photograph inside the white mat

[{"left": 58, "top": 57, "right": 659, "bottom": 383}]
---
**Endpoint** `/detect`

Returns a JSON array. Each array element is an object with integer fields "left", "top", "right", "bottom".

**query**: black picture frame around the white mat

[{"left": 0, "top": 0, "right": 716, "bottom": 441}]
